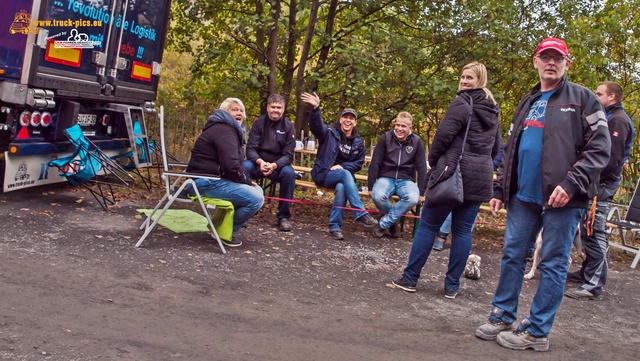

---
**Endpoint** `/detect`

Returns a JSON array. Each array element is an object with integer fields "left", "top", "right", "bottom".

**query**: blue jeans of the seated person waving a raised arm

[{"left": 320, "top": 169, "right": 367, "bottom": 232}]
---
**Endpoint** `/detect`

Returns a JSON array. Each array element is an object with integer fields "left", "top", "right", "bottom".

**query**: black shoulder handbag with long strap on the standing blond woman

[{"left": 424, "top": 97, "right": 473, "bottom": 208}]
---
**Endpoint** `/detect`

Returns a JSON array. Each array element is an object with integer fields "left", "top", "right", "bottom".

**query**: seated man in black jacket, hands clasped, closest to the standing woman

[{"left": 368, "top": 112, "right": 427, "bottom": 238}]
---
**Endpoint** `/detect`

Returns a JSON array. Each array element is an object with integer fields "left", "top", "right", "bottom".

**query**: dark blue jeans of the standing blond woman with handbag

[{"left": 404, "top": 202, "right": 480, "bottom": 290}]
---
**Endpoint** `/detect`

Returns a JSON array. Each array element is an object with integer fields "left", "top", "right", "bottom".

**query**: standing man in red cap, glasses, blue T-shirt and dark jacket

[{"left": 475, "top": 38, "right": 611, "bottom": 351}]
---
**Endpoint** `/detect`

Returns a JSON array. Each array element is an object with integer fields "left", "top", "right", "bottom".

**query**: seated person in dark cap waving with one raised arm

[{"left": 300, "top": 93, "right": 378, "bottom": 239}]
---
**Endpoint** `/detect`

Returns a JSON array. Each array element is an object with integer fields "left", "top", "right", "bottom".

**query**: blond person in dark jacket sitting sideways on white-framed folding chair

[{"left": 187, "top": 98, "right": 264, "bottom": 247}]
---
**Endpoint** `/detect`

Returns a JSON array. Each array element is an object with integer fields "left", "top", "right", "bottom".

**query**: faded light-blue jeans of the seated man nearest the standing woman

[{"left": 371, "top": 177, "right": 420, "bottom": 229}]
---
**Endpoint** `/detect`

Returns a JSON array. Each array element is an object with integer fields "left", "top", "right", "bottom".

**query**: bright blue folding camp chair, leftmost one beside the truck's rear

[{"left": 48, "top": 124, "right": 135, "bottom": 210}]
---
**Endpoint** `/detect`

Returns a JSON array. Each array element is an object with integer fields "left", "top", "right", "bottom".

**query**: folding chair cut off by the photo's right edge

[{"left": 607, "top": 180, "right": 640, "bottom": 268}]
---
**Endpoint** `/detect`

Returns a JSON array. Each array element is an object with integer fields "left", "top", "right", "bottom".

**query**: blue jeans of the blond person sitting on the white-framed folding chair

[{"left": 189, "top": 179, "right": 264, "bottom": 236}]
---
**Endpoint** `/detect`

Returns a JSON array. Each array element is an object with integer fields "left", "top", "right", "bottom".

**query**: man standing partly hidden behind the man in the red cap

[{"left": 564, "top": 82, "right": 633, "bottom": 300}]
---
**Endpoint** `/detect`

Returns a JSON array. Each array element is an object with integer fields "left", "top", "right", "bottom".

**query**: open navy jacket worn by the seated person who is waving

[{"left": 309, "top": 107, "right": 366, "bottom": 187}]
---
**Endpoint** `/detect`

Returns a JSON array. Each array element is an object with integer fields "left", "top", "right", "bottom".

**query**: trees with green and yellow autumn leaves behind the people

[{"left": 158, "top": 0, "right": 640, "bottom": 201}]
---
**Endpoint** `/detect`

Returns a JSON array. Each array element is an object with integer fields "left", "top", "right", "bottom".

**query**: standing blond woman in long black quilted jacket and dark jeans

[{"left": 393, "top": 62, "right": 500, "bottom": 298}]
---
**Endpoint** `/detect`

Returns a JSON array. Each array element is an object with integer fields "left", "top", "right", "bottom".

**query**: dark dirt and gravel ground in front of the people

[{"left": 0, "top": 187, "right": 640, "bottom": 361}]
